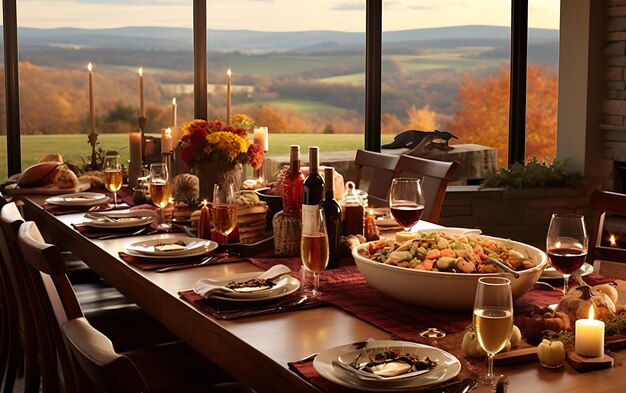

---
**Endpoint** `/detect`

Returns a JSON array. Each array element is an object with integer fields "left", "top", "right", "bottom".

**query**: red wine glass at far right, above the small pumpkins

[{"left": 546, "top": 213, "right": 589, "bottom": 293}]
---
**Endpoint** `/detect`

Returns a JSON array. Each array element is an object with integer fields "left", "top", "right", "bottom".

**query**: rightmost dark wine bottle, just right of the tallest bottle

[{"left": 321, "top": 167, "right": 341, "bottom": 269}]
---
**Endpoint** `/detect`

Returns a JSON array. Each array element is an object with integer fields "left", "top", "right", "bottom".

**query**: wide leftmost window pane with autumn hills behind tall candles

[{"left": 18, "top": 0, "right": 193, "bottom": 168}]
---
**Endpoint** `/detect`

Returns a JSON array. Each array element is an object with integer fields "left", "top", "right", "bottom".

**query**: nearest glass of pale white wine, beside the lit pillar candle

[{"left": 473, "top": 277, "right": 513, "bottom": 389}]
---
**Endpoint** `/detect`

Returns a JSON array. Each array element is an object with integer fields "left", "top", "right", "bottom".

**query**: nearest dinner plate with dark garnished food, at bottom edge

[{"left": 313, "top": 339, "right": 461, "bottom": 392}]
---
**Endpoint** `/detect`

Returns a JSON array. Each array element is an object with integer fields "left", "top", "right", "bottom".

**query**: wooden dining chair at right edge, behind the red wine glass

[{"left": 587, "top": 190, "right": 626, "bottom": 278}]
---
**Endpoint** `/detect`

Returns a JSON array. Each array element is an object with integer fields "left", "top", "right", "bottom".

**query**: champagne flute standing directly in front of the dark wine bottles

[{"left": 300, "top": 209, "right": 328, "bottom": 297}]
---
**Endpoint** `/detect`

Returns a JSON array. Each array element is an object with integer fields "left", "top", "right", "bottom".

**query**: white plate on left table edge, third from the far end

[{"left": 126, "top": 237, "right": 217, "bottom": 258}]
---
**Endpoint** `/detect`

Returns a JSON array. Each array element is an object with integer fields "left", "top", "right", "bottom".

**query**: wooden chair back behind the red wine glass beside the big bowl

[{"left": 396, "top": 155, "right": 459, "bottom": 224}]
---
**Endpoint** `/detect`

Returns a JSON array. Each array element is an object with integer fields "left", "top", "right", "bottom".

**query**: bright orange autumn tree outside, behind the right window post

[{"left": 447, "top": 65, "right": 558, "bottom": 166}]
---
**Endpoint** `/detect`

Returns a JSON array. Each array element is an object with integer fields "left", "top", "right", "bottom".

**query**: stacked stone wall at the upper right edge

[{"left": 599, "top": 0, "right": 626, "bottom": 192}]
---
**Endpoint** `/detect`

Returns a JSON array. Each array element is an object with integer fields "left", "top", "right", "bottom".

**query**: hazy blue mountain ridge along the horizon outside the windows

[{"left": 12, "top": 25, "right": 558, "bottom": 52}]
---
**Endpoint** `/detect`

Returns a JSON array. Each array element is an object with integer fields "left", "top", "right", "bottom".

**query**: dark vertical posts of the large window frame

[{"left": 2, "top": 0, "right": 528, "bottom": 175}]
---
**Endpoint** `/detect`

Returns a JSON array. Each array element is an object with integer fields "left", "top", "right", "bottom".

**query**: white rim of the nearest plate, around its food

[{"left": 313, "top": 340, "right": 461, "bottom": 392}]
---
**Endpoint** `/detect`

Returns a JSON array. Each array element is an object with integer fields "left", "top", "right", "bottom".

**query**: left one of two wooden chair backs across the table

[{"left": 354, "top": 149, "right": 400, "bottom": 206}]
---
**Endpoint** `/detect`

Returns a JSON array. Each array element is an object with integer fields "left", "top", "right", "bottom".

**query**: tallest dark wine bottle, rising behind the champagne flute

[{"left": 302, "top": 146, "right": 324, "bottom": 233}]
